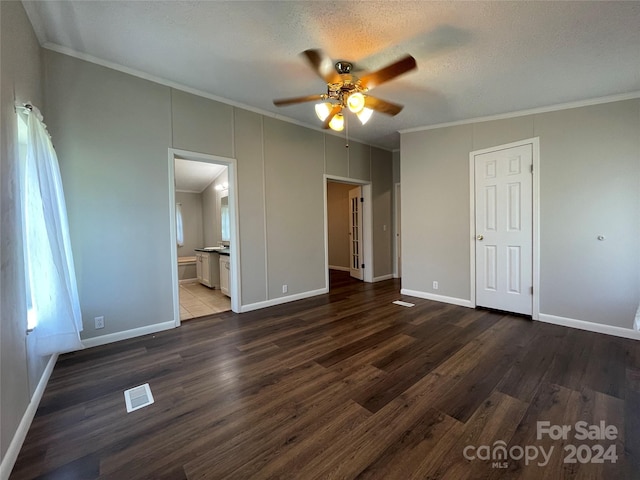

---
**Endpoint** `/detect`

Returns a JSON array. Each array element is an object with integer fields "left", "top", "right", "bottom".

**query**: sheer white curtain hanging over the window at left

[{"left": 22, "top": 107, "right": 83, "bottom": 355}]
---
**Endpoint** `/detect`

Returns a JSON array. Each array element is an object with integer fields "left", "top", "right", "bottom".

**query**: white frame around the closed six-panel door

[{"left": 469, "top": 137, "right": 540, "bottom": 320}]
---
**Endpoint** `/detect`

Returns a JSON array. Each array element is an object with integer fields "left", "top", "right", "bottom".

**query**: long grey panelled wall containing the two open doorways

[{"left": 44, "top": 51, "right": 391, "bottom": 338}]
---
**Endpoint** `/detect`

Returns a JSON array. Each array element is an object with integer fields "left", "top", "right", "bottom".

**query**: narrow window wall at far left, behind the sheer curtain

[{"left": 0, "top": 2, "right": 49, "bottom": 475}]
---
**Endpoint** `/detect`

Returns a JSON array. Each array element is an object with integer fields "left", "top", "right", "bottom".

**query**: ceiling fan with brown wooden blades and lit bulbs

[{"left": 273, "top": 49, "right": 417, "bottom": 131}]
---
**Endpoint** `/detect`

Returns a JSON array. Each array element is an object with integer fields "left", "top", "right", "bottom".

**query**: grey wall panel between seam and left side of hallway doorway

[{"left": 264, "top": 117, "right": 325, "bottom": 299}]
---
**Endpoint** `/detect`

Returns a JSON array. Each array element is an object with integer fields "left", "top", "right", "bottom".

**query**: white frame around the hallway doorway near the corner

[{"left": 322, "top": 173, "right": 373, "bottom": 291}]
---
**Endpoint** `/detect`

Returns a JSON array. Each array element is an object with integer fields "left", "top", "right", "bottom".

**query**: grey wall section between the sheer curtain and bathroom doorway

[{"left": 44, "top": 52, "right": 175, "bottom": 338}]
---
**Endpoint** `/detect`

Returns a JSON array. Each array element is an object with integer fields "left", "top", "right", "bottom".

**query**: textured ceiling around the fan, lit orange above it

[{"left": 23, "top": 1, "right": 640, "bottom": 148}]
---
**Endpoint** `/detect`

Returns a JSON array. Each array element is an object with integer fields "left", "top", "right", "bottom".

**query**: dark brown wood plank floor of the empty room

[{"left": 11, "top": 272, "right": 640, "bottom": 480}]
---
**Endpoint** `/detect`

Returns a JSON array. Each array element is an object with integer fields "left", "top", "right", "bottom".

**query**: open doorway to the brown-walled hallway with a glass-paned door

[{"left": 324, "top": 175, "right": 373, "bottom": 290}]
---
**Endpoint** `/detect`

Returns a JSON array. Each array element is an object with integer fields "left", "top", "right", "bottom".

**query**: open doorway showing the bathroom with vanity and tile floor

[{"left": 169, "top": 149, "right": 240, "bottom": 326}]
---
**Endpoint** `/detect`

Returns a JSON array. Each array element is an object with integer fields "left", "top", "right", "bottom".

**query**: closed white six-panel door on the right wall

[{"left": 474, "top": 144, "right": 533, "bottom": 315}]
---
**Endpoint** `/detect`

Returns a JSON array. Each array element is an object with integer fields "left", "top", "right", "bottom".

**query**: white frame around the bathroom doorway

[{"left": 169, "top": 148, "right": 242, "bottom": 327}]
